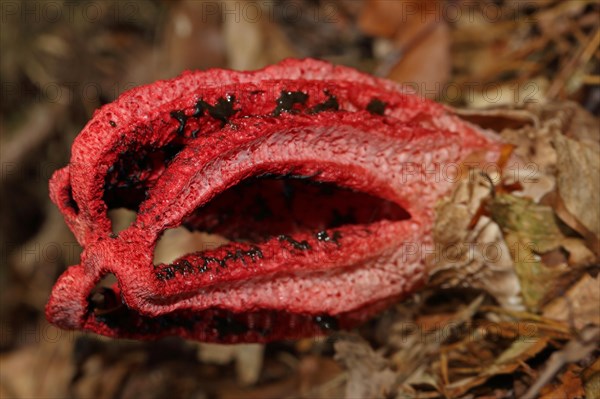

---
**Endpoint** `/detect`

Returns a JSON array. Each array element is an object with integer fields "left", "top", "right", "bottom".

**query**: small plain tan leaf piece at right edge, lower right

[{"left": 543, "top": 274, "right": 600, "bottom": 329}]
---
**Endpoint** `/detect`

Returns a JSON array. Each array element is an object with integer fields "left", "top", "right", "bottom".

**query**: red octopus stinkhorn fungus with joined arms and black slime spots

[{"left": 46, "top": 59, "right": 500, "bottom": 342}]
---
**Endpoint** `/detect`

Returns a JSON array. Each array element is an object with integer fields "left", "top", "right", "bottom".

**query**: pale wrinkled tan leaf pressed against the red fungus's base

[{"left": 428, "top": 171, "right": 521, "bottom": 309}]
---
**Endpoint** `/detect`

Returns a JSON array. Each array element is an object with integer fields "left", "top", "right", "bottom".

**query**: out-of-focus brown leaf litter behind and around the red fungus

[{"left": 0, "top": 0, "right": 600, "bottom": 398}]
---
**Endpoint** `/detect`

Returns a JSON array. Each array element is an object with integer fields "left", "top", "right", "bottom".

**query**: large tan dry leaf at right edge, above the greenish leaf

[{"left": 494, "top": 102, "right": 600, "bottom": 219}]
